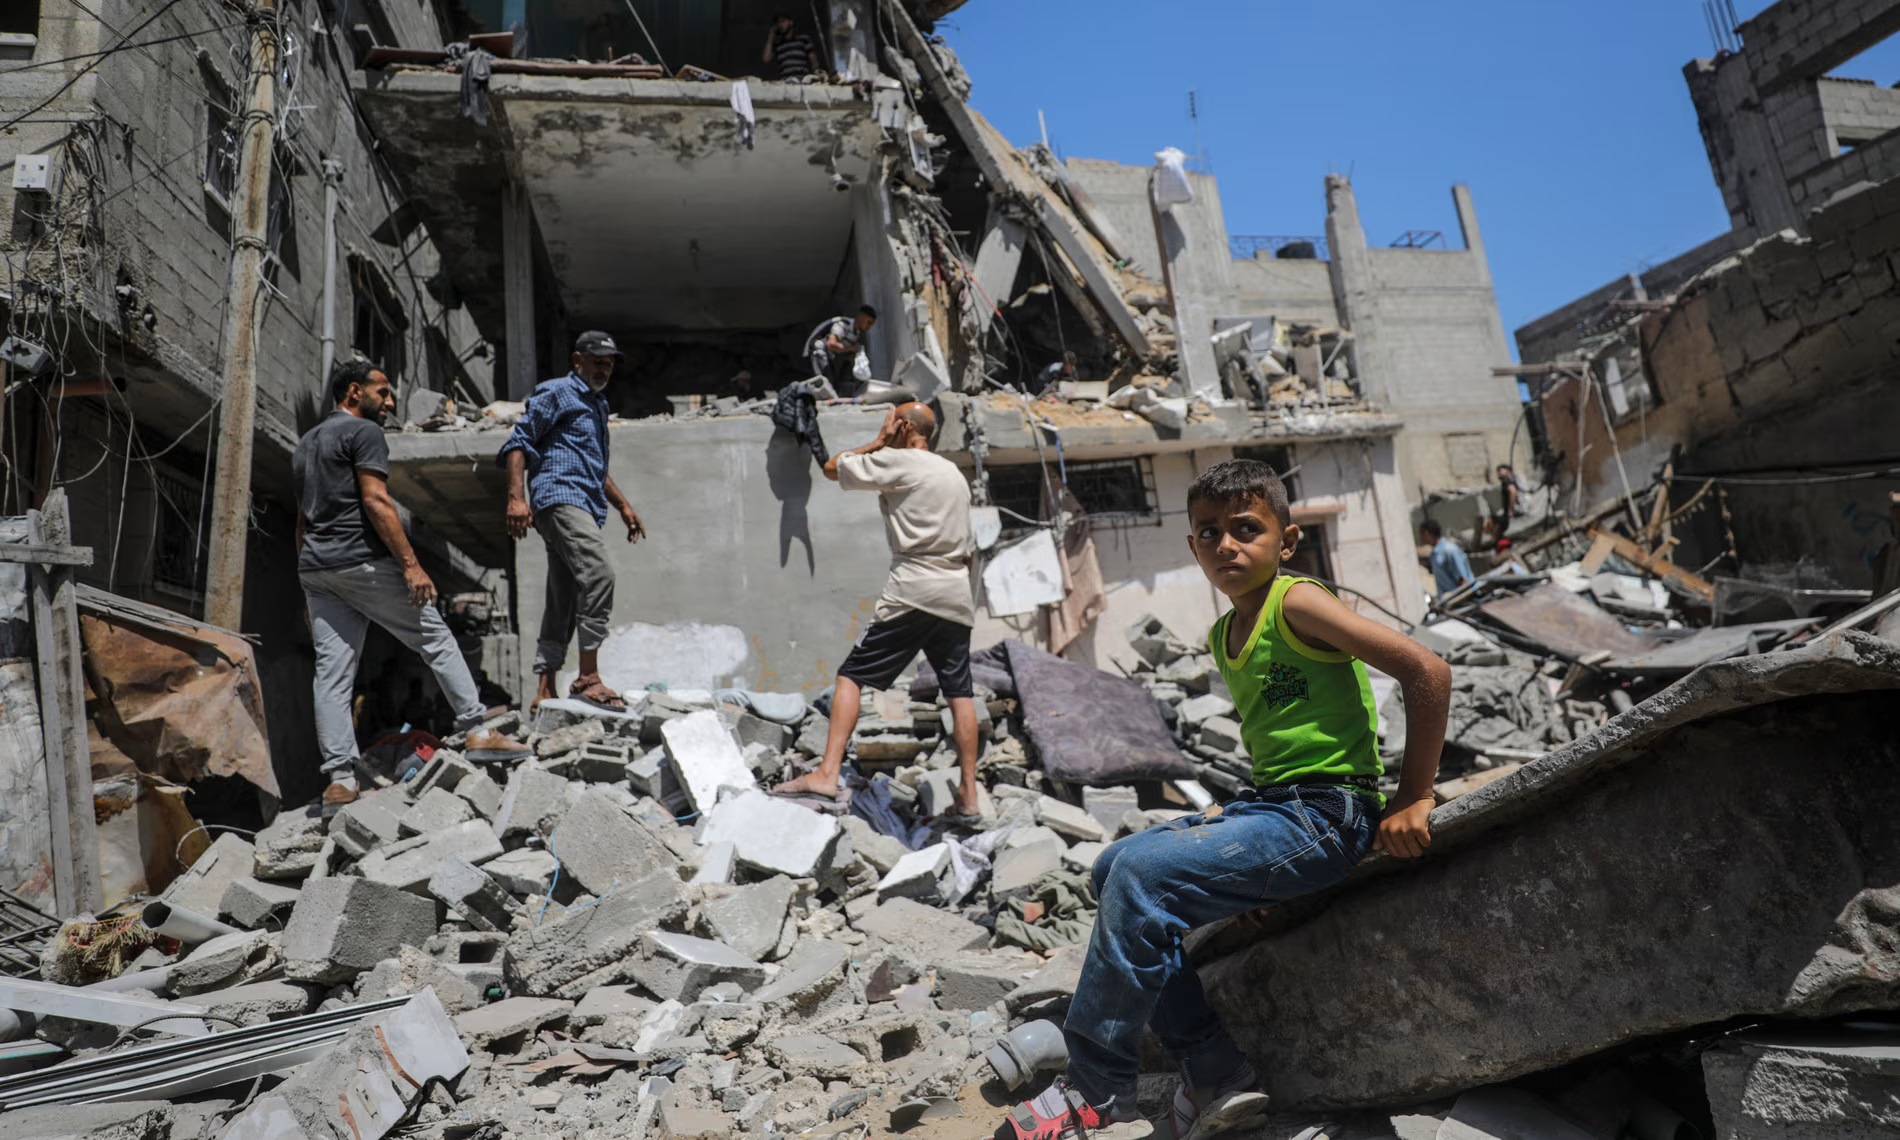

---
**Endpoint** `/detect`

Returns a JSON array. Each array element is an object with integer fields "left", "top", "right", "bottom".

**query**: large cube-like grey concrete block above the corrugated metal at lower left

[{"left": 283, "top": 877, "right": 438, "bottom": 982}]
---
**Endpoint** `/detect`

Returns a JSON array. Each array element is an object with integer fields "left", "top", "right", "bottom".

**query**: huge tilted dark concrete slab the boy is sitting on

[{"left": 1191, "top": 633, "right": 1900, "bottom": 1108}]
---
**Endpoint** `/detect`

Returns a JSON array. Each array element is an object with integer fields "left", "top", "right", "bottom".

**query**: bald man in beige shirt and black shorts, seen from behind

[{"left": 775, "top": 403, "right": 977, "bottom": 823}]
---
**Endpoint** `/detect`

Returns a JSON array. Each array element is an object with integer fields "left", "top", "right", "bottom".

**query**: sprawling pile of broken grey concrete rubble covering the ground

[{"left": 0, "top": 596, "right": 1892, "bottom": 1140}]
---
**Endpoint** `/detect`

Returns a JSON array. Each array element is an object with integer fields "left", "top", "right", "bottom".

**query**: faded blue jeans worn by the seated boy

[{"left": 1064, "top": 789, "right": 1378, "bottom": 1104}]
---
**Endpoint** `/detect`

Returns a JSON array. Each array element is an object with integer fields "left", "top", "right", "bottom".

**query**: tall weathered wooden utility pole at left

[{"left": 205, "top": 0, "right": 277, "bottom": 629}]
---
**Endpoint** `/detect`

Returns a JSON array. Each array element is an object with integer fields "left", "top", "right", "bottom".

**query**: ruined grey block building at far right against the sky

[{"left": 1516, "top": 0, "right": 1900, "bottom": 618}]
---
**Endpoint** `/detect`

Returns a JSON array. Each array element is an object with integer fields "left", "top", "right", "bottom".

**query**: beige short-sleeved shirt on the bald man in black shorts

[{"left": 838, "top": 447, "right": 977, "bottom": 625}]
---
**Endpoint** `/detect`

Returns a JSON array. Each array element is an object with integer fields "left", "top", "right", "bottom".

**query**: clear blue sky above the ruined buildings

[{"left": 939, "top": 0, "right": 1900, "bottom": 351}]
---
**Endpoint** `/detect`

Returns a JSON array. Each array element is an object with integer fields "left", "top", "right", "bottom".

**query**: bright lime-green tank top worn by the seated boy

[{"left": 1207, "top": 576, "right": 1383, "bottom": 800}]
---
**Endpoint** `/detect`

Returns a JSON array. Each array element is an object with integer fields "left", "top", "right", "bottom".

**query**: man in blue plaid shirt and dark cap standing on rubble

[{"left": 496, "top": 324, "right": 646, "bottom": 711}]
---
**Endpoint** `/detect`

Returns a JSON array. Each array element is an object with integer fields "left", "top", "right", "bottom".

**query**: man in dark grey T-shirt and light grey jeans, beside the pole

[{"left": 291, "top": 361, "right": 526, "bottom": 808}]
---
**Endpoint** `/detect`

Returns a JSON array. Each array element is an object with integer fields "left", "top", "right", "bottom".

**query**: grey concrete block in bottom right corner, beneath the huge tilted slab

[{"left": 1702, "top": 1028, "right": 1900, "bottom": 1140}]
